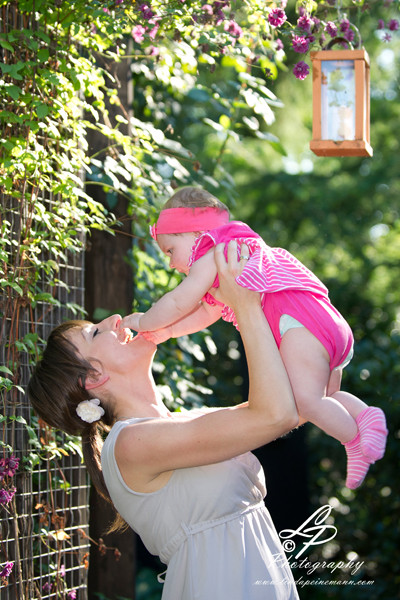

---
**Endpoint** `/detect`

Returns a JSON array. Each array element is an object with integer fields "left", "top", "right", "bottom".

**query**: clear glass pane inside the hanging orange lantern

[{"left": 321, "top": 60, "right": 356, "bottom": 141}]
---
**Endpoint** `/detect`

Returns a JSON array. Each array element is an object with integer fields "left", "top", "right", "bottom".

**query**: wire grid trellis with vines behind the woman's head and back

[{"left": 0, "top": 195, "right": 89, "bottom": 600}]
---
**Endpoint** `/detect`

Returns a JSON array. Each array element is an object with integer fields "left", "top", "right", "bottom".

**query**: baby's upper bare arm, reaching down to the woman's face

[{"left": 120, "top": 252, "right": 217, "bottom": 335}]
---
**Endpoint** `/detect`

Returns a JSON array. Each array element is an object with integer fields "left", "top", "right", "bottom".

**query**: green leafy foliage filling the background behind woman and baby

[{"left": 0, "top": 0, "right": 400, "bottom": 600}]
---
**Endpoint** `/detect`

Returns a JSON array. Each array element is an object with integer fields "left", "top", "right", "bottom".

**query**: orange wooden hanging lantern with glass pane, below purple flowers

[{"left": 310, "top": 40, "right": 372, "bottom": 156}]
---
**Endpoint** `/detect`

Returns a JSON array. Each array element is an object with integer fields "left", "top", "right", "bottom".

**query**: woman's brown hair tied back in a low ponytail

[{"left": 28, "top": 321, "right": 126, "bottom": 531}]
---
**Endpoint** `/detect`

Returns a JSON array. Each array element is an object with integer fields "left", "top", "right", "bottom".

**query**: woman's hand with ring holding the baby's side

[{"left": 212, "top": 240, "right": 260, "bottom": 310}]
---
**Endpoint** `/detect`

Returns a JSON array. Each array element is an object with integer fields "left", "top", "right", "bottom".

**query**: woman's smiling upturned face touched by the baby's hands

[{"left": 66, "top": 315, "right": 157, "bottom": 380}]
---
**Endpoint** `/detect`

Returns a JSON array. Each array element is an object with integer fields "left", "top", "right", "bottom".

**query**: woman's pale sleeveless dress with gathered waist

[{"left": 101, "top": 419, "right": 298, "bottom": 600}]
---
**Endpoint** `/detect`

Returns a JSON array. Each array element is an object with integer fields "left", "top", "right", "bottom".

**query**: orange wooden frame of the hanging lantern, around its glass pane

[{"left": 310, "top": 49, "right": 373, "bottom": 156}]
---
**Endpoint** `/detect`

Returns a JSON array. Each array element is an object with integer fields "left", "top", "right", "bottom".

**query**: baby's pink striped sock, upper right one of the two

[{"left": 356, "top": 406, "right": 388, "bottom": 461}]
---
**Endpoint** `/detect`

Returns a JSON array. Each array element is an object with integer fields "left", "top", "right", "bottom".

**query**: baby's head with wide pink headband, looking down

[{"left": 150, "top": 187, "right": 229, "bottom": 275}]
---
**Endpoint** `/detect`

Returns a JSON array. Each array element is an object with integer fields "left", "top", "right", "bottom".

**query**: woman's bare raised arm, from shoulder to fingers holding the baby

[{"left": 116, "top": 243, "right": 298, "bottom": 481}]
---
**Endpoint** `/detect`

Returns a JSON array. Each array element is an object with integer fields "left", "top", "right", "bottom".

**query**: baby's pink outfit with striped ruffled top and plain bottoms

[{"left": 189, "top": 221, "right": 353, "bottom": 370}]
